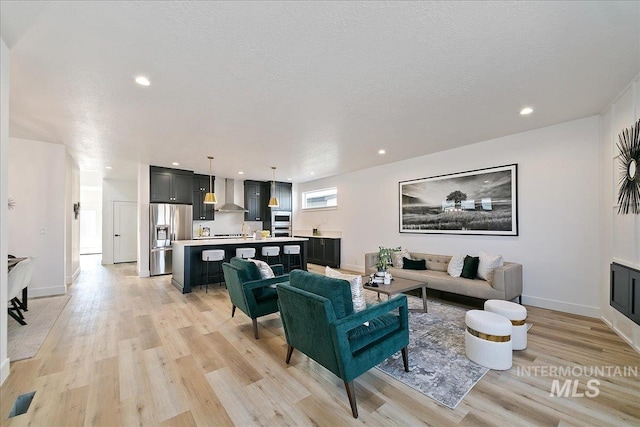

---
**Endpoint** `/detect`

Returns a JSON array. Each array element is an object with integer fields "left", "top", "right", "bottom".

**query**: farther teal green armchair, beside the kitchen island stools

[{"left": 222, "top": 257, "right": 289, "bottom": 339}]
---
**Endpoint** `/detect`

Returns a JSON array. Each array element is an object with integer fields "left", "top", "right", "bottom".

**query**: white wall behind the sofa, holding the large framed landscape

[{"left": 294, "top": 116, "right": 602, "bottom": 317}]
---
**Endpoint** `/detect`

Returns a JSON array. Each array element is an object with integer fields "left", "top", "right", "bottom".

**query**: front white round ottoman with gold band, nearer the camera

[{"left": 464, "top": 310, "right": 512, "bottom": 370}]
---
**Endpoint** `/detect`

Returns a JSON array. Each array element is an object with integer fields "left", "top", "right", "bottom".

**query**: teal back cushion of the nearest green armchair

[{"left": 289, "top": 270, "right": 353, "bottom": 319}]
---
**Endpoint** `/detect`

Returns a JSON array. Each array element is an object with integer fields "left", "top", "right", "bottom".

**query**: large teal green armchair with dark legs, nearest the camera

[{"left": 277, "top": 270, "right": 409, "bottom": 418}]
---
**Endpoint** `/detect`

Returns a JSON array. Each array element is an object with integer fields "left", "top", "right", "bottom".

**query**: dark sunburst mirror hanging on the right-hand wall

[{"left": 616, "top": 120, "right": 640, "bottom": 215}]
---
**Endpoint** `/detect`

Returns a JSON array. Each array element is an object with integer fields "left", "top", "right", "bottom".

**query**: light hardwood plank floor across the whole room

[{"left": 0, "top": 256, "right": 640, "bottom": 426}]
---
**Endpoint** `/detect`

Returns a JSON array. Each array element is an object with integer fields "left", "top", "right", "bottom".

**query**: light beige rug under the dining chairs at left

[{"left": 7, "top": 295, "right": 71, "bottom": 362}]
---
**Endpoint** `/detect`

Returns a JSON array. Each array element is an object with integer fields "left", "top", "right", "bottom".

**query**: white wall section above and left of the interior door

[{"left": 102, "top": 179, "right": 138, "bottom": 265}]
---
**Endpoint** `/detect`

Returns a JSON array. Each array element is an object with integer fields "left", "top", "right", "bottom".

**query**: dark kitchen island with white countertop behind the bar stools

[{"left": 171, "top": 237, "right": 309, "bottom": 294}]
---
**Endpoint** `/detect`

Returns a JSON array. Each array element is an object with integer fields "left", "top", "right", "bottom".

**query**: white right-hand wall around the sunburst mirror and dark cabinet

[{"left": 599, "top": 75, "right": 640, "bottom": 352}]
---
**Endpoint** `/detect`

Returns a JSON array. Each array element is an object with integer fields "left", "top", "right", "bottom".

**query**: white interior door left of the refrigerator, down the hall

[{"left": 113, "top": 202, "right": 138, "bottom": 263}]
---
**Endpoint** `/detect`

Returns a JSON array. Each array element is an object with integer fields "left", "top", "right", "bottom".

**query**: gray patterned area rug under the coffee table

[{"left": 365, "top": 291, "right": 489, "bottom": 409}]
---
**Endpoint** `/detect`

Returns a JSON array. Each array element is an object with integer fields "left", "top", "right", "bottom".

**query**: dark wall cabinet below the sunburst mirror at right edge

[{"left": 609, "top": 262, "right": 640, "bottom": 325}]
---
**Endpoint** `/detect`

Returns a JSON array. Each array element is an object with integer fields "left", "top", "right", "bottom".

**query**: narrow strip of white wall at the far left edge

[{"left": 0, "top": 38, "right": 10, "bottom": 384}]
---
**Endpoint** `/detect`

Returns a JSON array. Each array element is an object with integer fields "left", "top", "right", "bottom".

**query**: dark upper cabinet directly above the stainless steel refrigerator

[{"left": 149, "top": 166, "right": 193, "bottom": 205}]
